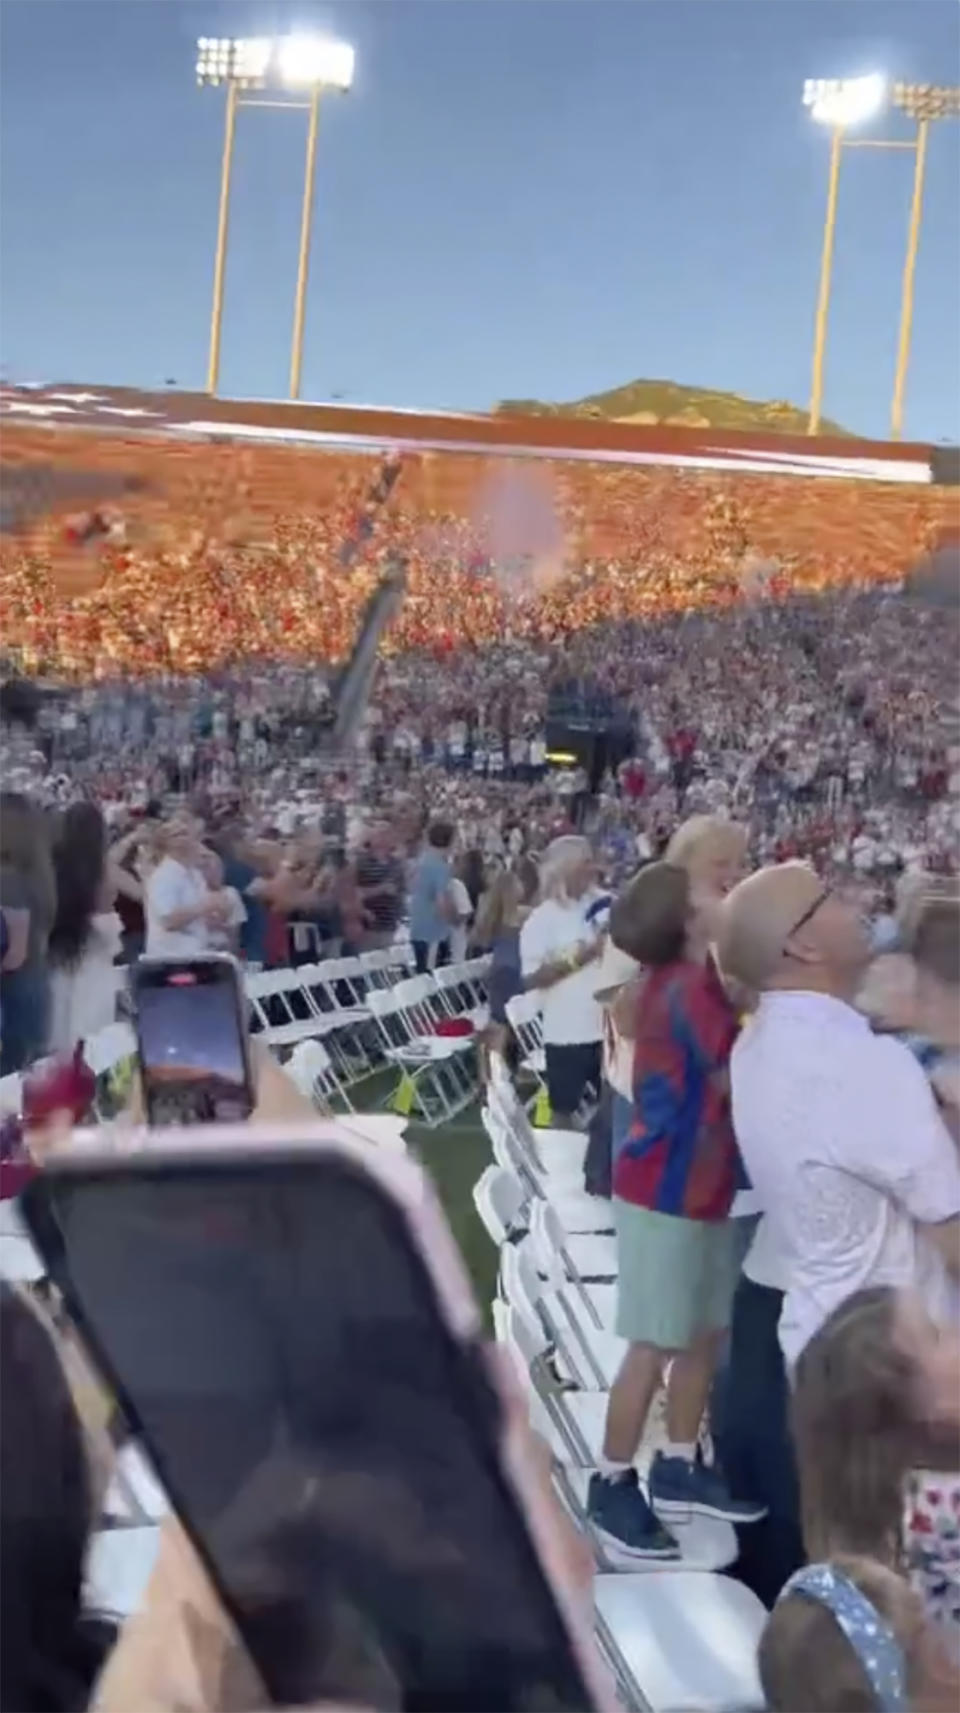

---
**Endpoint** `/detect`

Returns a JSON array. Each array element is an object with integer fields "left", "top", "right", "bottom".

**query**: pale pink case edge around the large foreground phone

[{"left": 24, "top": 1119, "right": 617, "bottom": 1713}]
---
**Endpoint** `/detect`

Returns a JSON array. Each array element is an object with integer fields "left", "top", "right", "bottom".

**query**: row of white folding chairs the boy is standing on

[{"left": 473, "top": 1055, "right": 765, "bottom": 1710}]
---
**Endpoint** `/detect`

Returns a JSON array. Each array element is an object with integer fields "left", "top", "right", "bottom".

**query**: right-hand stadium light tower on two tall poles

[{"left": 804, "top": 72, "right": 960, "bottom": 440}]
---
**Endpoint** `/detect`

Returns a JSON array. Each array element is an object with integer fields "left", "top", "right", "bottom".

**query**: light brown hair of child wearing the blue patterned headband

[{"left": 758, "top": 1557, "right": 958, "bottom": 1713}]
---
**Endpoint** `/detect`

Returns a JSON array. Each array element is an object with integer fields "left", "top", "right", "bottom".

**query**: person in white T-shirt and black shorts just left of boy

[{"left": 519, "top": 834, "right": 603, "bottom": 1125}]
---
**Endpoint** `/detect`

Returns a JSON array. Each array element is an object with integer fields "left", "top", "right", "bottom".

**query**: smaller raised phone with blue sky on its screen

[{"left": 134, "top": 958, "right": 254, "bottom": 1125}]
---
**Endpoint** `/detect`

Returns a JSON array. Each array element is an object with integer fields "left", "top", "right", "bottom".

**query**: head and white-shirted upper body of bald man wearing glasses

[{"left": 717, "top": 862, "right": 960, "bottom": 1367}]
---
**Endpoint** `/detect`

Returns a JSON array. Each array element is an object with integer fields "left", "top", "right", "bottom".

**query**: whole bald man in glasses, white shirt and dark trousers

[{"left": 711, "top": 862, "right": 960, "bottom": 1605}]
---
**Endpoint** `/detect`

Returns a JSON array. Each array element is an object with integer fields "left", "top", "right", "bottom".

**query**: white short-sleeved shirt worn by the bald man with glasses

[{"left": 730, "top": 992, "right": 960, "bottom": 1365}]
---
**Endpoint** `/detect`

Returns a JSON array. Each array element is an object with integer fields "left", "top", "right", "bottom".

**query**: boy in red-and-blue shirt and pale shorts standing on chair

[{"left": 590, "top": 862, "right": 763, "bottom": 1559}]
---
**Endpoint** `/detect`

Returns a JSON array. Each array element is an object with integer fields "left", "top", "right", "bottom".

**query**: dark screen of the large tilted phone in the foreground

[{"left": 24, "top": 1155, "right": 591, "bottom": 1713}]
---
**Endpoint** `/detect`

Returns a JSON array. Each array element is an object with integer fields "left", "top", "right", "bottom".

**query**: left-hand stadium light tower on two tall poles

[{"left": 197, "top": 36, "right": 355, "bottom": 399}]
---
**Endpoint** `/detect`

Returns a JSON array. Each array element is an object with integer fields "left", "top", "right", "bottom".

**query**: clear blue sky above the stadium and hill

[{"left": 0, "top": 0, "right": 960, "bottom": 440}]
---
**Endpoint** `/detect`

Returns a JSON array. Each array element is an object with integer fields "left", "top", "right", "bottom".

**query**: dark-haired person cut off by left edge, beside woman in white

[{"left": 0, "top": 791, "right": 57, "bottom": 1076}]
